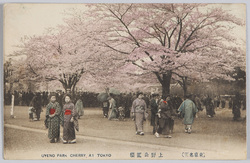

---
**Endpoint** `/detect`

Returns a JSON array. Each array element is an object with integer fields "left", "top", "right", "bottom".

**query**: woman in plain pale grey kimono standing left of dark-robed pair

[{"left": 131, "top": 92, "right": 147, "bottom": 135}]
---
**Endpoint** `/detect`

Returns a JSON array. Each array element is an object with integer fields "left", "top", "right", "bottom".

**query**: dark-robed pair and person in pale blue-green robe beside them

[{"left": 150, "top": 94, "right": 198, "bottom": 138}]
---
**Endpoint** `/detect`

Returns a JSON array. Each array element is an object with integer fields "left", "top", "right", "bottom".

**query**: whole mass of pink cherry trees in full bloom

[{"left": 10, "top": 4, "right": 245, "bottom": 95}]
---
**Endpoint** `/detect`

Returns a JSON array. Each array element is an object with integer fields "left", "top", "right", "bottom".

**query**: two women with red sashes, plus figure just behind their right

[{"left": 44, "top": 94, "right": 80, "bottom": 144}]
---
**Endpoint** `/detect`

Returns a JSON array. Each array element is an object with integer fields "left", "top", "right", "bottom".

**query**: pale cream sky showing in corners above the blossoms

[{"left": 4, "top": 4, "right": 246, "bottom": 61}]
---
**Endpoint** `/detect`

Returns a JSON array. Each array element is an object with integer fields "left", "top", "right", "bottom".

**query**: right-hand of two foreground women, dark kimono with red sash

[{"left": 63, "top": 95, "right": 77, "bottom": 144}]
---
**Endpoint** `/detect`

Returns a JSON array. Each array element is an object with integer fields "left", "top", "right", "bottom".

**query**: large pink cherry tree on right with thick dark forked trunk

[{"left": 85, "top": 4, "right": 244, "bottom": 95}]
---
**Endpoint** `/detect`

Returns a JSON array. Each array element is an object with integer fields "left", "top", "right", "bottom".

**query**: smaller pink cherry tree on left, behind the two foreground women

[{"left": 12, "top": 9, "right": 129, "bottom": 93}]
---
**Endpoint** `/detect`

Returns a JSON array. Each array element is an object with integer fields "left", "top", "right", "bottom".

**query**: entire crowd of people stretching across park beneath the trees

[{"left": 5, "top": 92, "right": 246, "bottom": 143}]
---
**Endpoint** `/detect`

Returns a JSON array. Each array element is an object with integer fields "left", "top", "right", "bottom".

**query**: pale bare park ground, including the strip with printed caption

[{"left": 4, "top": 106, "right": 247, "bottom": 160}]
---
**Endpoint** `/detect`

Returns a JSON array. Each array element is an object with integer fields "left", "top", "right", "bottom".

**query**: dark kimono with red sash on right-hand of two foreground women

[{"left": 63, "top": 103, "right": 77, "bottom": 141}]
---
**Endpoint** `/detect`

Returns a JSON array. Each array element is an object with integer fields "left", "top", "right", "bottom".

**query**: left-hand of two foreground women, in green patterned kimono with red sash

[{"left": 45, "top": 94, "right": 63, "bottom": 143}]
